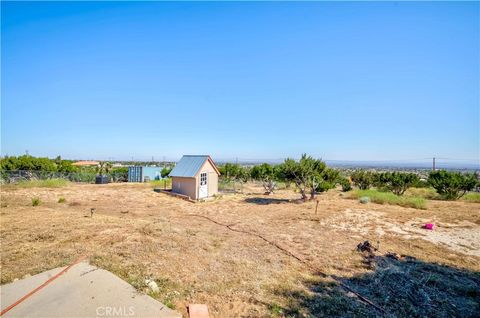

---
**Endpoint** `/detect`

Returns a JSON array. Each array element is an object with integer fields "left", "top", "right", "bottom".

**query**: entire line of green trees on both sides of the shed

[{"left": 0, "top": 154, "right": 480, "bottom": 200}]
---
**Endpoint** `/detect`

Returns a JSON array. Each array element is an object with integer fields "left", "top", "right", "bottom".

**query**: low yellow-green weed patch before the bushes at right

[{"left": 350, "top": 189, "right": 427, "bottom": 209}]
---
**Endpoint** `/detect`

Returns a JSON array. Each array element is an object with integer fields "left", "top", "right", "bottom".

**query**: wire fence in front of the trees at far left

[{"left": 0, "top": 170, "right": 128, "bottom": 184}]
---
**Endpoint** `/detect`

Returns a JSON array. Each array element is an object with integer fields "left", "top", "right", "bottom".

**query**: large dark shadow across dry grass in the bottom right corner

[{"left": 269, "top": 256, "right": 480, "bottom": 317}]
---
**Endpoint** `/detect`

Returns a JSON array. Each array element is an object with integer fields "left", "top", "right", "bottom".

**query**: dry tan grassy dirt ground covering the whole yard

[{"left": 1, "top": 184, "right": 480, "bottom": 317}]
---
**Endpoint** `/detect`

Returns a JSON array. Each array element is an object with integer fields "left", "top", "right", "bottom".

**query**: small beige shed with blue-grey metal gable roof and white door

[{"left": 169, "top": 155, "right": 220, "bottom": 200}]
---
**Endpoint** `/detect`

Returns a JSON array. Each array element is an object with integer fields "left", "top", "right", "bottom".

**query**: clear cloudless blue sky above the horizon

[{"left": 1, "top": 1, "right": 480, "bottom": 161}]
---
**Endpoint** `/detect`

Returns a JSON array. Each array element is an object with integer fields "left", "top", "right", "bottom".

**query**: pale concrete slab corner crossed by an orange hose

[{"left": 0, "top": 262, "right": 182, "bottom": 318}]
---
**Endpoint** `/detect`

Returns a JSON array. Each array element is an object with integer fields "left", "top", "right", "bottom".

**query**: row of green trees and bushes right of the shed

[{"left": 219, "top": 154, "right": 480, "bottom": 200}]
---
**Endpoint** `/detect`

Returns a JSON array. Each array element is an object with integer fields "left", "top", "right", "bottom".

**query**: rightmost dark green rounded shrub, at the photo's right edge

[{"left": 428, "top": 170, "right": 478, "bottom": 200}]
